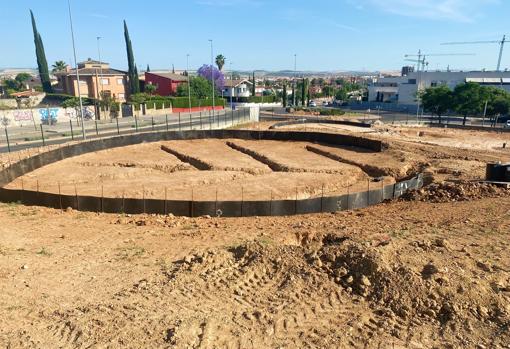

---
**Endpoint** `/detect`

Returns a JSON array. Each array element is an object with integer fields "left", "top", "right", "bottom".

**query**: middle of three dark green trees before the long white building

[{"left": 453, "top": 82, "right": 485, "bottom": 125}]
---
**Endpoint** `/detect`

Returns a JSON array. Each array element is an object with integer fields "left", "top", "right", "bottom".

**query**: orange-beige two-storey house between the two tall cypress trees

[{"left": 55, "top": 59, "right": 129, "bottom": 102}]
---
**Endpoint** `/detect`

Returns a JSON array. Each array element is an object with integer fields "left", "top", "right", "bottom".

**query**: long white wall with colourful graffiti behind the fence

[{"left": 0, "top": 106, "right": 95, "bottom": 127}]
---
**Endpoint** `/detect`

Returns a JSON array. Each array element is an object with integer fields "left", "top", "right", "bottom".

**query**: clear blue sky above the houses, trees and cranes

[{"left": 0, "top": 0, "right": 510, "bottom": 70}]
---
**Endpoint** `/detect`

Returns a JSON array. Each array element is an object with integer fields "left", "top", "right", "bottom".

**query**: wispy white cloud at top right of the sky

[{"left": 356, "top": 0, "right": 501, "bottom": 22}]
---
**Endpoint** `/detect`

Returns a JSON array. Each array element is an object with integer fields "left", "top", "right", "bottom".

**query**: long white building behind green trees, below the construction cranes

[{"left": 368, "top": 71, "right": 510, "bottom": 106}]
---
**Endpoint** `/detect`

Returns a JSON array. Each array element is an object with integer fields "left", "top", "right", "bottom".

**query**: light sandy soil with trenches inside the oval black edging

[{"left": 7, "top": 140, "right": 378, "bottom": 201}]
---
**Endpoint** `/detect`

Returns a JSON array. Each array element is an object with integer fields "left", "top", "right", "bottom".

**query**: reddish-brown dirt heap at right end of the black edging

[{"left": 401, "top": 181, "right": 510, "bottom": 203}]
